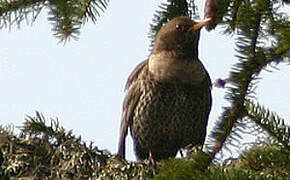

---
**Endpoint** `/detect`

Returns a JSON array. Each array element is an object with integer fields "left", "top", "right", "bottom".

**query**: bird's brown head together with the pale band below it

[{"left": 148, "top": 17, "right": 209, "bottom": 84}]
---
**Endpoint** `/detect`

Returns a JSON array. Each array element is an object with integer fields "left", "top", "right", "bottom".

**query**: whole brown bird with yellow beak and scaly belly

[{"left": 117, "top": 16, "right": 212, "bottom": 161}]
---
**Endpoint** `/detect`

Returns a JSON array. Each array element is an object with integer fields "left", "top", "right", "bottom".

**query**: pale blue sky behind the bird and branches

[{"left": 0, "top": 0, "right": 290, "bottom": 160}]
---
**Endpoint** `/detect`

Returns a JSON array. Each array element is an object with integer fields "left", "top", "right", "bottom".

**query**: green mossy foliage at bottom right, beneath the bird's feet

[{"left": 154, "top": 144, "right": 290, "bottom": 180}]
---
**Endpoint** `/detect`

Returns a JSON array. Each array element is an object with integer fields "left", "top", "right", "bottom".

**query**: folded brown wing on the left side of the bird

[{"left": 118, "top": 60, "right": 148, "bottom": 158}]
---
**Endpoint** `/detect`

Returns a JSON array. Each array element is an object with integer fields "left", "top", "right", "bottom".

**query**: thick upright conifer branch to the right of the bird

[{"left": 206, "top": 0, "right": 285, "bottom": 162}]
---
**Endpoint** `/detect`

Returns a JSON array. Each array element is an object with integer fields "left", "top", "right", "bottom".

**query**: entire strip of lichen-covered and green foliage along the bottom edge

[{"left": 0, "top": 112, "right": 290, "bottom": 180}]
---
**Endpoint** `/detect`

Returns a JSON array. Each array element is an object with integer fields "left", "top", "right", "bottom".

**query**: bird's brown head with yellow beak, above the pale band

[{"left": 152, "top": 16, "right": 210, "bottom": 58}]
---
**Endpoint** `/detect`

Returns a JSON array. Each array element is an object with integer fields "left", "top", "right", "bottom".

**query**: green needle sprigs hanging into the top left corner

[{"left": 0, "top": 0, "right": 109, "bottom": 41}]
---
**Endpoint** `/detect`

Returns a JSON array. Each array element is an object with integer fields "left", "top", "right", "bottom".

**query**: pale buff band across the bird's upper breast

[{"left": 148, "top": 52, "right": 206, "bottom": 85}]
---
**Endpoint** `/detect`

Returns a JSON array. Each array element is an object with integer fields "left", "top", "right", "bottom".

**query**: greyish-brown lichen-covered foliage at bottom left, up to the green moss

[{"left": 0, "top": 112, "right": 156, "bottom": 179}]
